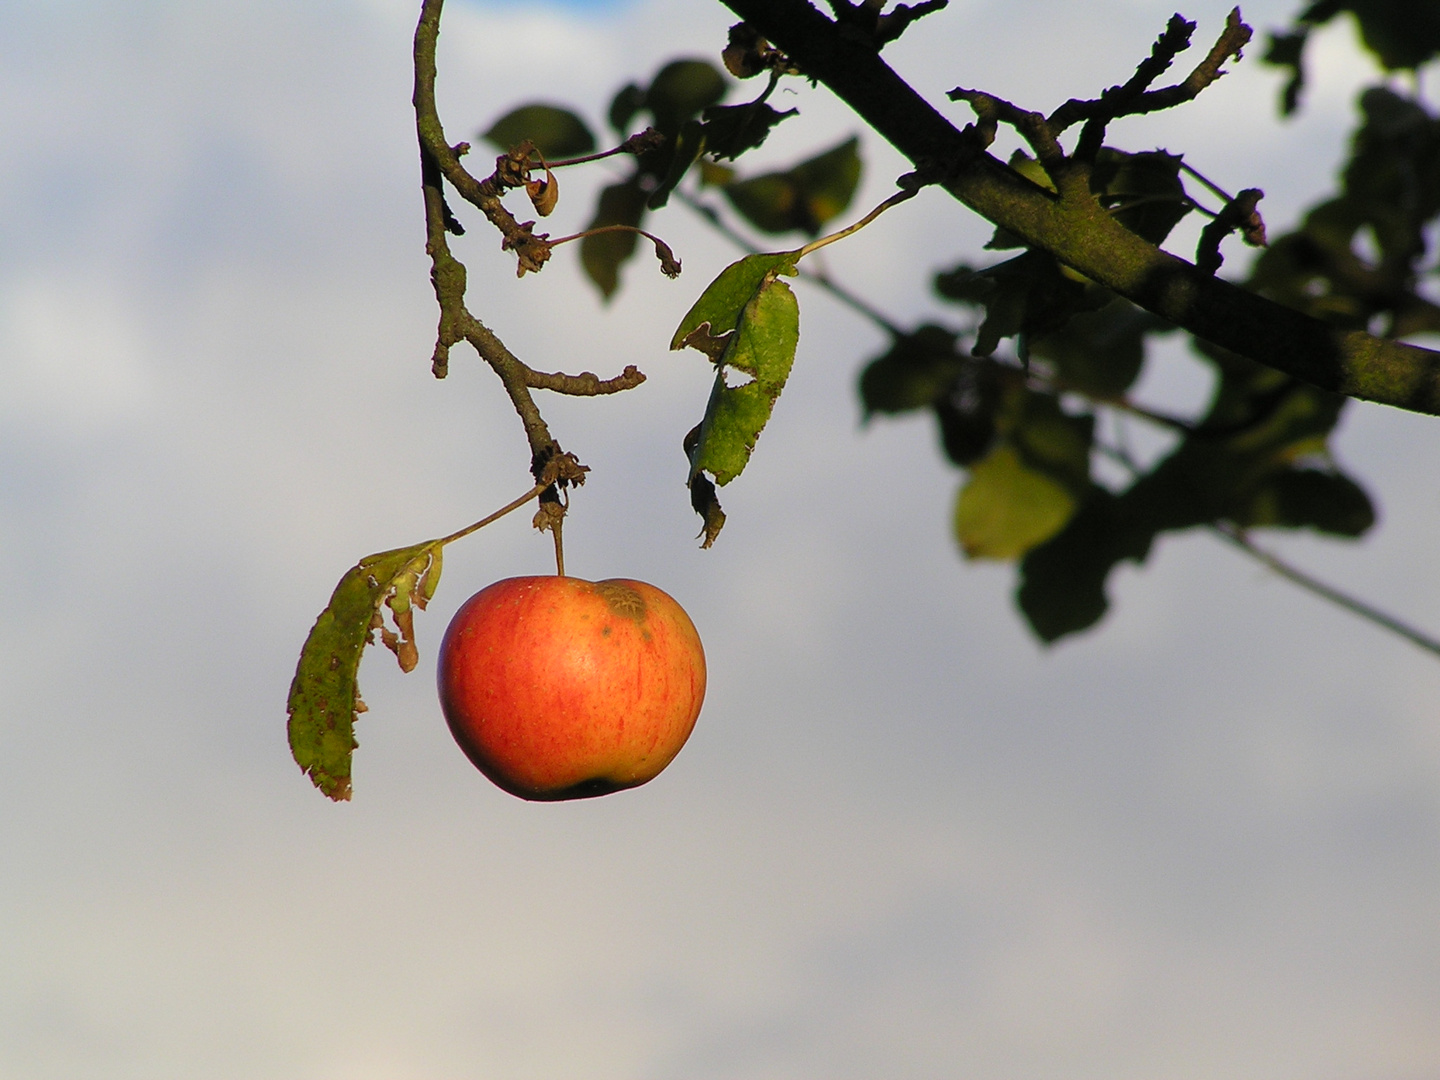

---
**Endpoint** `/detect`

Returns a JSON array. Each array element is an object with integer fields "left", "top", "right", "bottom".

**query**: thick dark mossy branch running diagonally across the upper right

[{"left": 724, "top": 0, "right": 1440, "bottom": 415}]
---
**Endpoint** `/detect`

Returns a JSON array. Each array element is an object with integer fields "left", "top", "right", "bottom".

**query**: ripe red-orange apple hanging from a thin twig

[{"left": 438, "top": 576, "right": 706, "bottom": 801}]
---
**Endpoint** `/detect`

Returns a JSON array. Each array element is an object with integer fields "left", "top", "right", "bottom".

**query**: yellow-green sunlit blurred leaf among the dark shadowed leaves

[{"left": 955, "top": 444, "right": 1076, "bottom": 559}]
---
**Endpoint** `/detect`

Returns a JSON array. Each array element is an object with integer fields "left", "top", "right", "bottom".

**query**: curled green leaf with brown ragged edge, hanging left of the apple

[{"left": 280, "top": 540, "right": 442, "bottom": 799}]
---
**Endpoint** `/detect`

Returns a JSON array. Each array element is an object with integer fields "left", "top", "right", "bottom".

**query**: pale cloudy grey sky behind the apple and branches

[{"left": 0, "top": 0, "right": 1440, "bottom": 1080}]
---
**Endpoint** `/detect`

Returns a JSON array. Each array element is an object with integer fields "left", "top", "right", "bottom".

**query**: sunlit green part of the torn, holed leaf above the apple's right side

[{"left": 677, "top": 269, "right": 801, "bottom": 487}]
